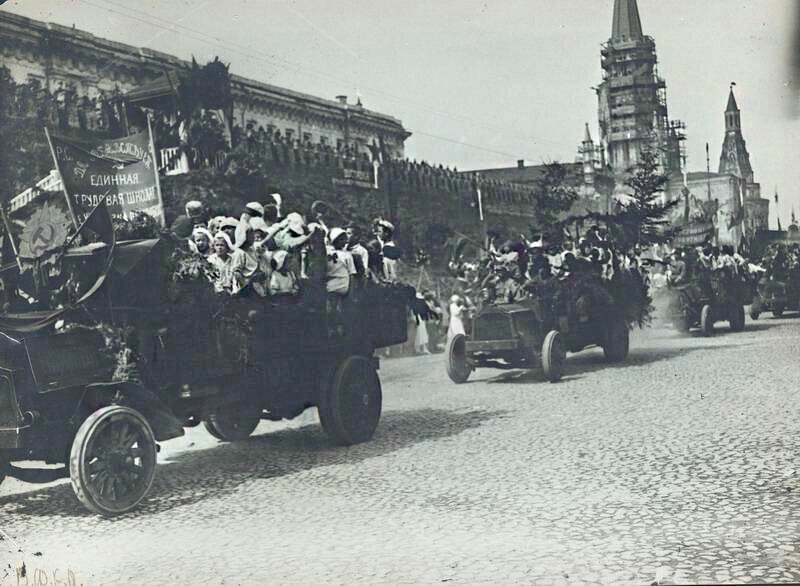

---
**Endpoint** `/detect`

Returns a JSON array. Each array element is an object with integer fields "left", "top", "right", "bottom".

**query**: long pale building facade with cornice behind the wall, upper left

[{"left": 0, "top": 12, "right": 410, "bottom": 158}]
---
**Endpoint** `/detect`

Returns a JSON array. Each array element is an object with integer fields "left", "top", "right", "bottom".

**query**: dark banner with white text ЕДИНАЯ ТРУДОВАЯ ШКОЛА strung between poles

[{"left": 52, "top": 132, "right": 163, "bottom": 222}]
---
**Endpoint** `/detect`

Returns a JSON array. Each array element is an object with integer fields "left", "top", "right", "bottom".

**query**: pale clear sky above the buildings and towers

[{"left": 2, "top": 0, "right": 800, "bottom": 228}]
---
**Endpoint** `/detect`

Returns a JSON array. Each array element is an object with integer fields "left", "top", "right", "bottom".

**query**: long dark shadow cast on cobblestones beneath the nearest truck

[{"left": 0, "top": 409, "right": 504, "bottom": 521}]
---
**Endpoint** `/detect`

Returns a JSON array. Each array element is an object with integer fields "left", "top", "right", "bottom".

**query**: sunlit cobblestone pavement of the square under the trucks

[{"left": 0, "top": 318, "right": 800, "bottom": 584}]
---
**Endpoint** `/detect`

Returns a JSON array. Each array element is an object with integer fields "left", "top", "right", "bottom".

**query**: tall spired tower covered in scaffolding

[{"left": 597, "top": 0, "right": 684, "bottom": 180}]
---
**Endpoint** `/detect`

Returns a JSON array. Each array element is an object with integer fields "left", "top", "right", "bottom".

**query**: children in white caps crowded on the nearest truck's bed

[{"left": 172, "top": 194, "right": 401, "bottom": 302}]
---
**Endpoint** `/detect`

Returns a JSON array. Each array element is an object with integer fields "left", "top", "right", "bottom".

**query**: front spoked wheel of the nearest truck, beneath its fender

[{"left": 69, "top": 405, "right": 156, "bottom": 516}]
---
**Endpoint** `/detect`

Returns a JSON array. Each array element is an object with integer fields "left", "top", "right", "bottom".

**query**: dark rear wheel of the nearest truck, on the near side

[{"left": 319, "top": 356, "right": 383, "bottom": 446}]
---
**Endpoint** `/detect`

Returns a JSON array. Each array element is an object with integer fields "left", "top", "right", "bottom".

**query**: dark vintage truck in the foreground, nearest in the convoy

[{"left": 0, "top": 239, "right": 413, "bottom": 515}]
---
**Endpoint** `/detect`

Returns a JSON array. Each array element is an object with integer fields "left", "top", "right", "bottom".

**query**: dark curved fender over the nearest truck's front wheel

[{"left": 79, "top": 381, "right": 184, "bottom": 441}]
